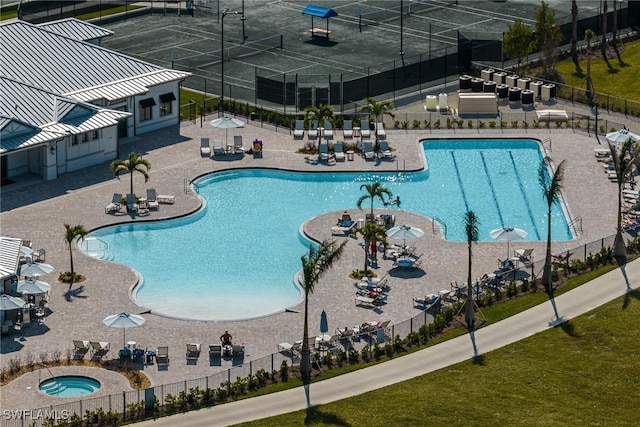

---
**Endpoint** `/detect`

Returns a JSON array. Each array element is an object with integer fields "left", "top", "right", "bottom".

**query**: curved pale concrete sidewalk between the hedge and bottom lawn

[{"left": 139, "top": 259, "right": 640, "bottom": 427}]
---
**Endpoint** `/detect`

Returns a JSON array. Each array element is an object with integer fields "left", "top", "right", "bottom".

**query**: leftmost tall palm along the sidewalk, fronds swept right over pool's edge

[{"left": 300, "top": 240, "right": 347, "bottom": 384}]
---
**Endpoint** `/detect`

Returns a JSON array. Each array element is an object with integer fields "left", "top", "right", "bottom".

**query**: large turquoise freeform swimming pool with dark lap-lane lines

[{"left": 87, "top": 139, "right": 571, "bottom": 320}]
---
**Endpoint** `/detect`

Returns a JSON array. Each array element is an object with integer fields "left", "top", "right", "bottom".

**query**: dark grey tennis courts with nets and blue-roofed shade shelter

[{"left": 103, "top": 0, "right": 598, "bottom": 106}]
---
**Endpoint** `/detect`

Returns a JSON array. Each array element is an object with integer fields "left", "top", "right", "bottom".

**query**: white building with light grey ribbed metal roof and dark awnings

[{"left": 0, "top": 19, "right": 191, "bottom": 180}]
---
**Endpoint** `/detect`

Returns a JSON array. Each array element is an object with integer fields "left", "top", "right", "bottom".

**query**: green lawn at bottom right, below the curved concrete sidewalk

[{"left": 242, "top": 291, "right": 640, "bottom": 426}]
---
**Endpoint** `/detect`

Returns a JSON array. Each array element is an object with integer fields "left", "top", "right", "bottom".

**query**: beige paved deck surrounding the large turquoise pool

[{"left": 0, "top": 98, "right": 637, "bottom": 409}]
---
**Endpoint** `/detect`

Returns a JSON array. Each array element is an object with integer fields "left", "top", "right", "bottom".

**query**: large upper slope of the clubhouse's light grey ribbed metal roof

[{"left": 0, "top": 21, "right": 191, "bottom": 98}]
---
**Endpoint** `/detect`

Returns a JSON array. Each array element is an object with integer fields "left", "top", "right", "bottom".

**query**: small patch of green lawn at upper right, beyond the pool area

[{"left": 558, "top": 41, "right": 640, "bottom": 102}]
